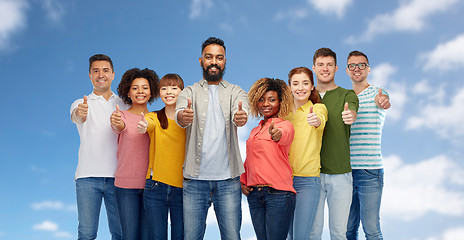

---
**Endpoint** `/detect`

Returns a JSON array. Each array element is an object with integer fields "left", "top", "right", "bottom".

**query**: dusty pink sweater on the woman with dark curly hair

[{"left": 112, "top": 111, "right": 150, "bottom": 189}]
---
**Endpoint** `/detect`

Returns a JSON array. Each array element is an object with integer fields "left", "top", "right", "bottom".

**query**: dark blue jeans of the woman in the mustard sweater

[{"left": 143, "top": 179, "right": 184, "bottom": 240}]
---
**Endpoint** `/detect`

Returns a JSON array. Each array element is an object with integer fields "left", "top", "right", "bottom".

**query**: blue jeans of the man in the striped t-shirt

[{"left": 346, "top": 169, "right": 383, "bottom": 240}]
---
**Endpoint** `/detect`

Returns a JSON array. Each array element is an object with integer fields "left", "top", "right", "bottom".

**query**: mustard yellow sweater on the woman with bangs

[{"left": 145, "top": 112, "right": 185, "bottom": 188}]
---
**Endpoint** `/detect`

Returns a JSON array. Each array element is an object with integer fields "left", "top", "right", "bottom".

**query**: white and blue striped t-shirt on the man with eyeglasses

[{"left": 350, "top": 86, "right": 386, "bottom": 169}]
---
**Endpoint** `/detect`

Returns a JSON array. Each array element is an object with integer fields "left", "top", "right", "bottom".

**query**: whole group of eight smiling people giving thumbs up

[{"left": 70, "top": 37, "right": 390, "bottom": 240}]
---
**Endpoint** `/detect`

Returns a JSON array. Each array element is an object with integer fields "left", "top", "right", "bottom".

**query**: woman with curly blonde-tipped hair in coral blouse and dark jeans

[{"left": 240, "top": 78, "right": 296, "bottom": 240}]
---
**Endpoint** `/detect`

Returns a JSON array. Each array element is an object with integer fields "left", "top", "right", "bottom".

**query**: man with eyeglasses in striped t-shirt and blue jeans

[{"left": 346, "top": 51, "right": 391, "bottom": 240}]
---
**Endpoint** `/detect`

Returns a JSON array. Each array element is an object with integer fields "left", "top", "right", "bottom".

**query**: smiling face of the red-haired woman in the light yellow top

[{"left": 290, "top": 72, "right": 314, "bottom": 106}]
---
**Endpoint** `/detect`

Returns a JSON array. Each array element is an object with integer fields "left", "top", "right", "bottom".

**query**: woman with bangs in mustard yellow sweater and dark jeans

[{"left": 138, "top": 73, "right": 185, "bottom": 240}]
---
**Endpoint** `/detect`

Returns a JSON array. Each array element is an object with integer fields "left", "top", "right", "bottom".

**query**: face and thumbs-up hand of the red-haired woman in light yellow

[{"left": 290, "top": 72, "right": 321, "bottom": 127}]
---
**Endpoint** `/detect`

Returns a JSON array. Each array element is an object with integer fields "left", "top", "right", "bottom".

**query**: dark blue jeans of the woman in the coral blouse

[{"left": 247, "top": 187, "right": 295, "bottom": 240}]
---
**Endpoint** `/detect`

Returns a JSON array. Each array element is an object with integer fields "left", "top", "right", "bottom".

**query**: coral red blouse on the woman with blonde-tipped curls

[{"left": 240, "top": 118, "right": 296, "bottom": 193}]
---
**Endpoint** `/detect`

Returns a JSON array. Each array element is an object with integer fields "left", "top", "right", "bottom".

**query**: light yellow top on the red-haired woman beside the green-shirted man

[{"left": 286, "top": 100, "right": 328, "bottom": 177}]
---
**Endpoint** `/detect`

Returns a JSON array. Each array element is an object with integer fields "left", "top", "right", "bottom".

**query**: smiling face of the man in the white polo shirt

[{"left": 89, "top": 61, "right": 114, "bottom": 95}]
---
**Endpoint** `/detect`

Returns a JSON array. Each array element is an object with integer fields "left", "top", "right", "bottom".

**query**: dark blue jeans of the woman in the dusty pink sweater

[{"left": 116, "top": 187, "right": 148, "bottom": 240}]
